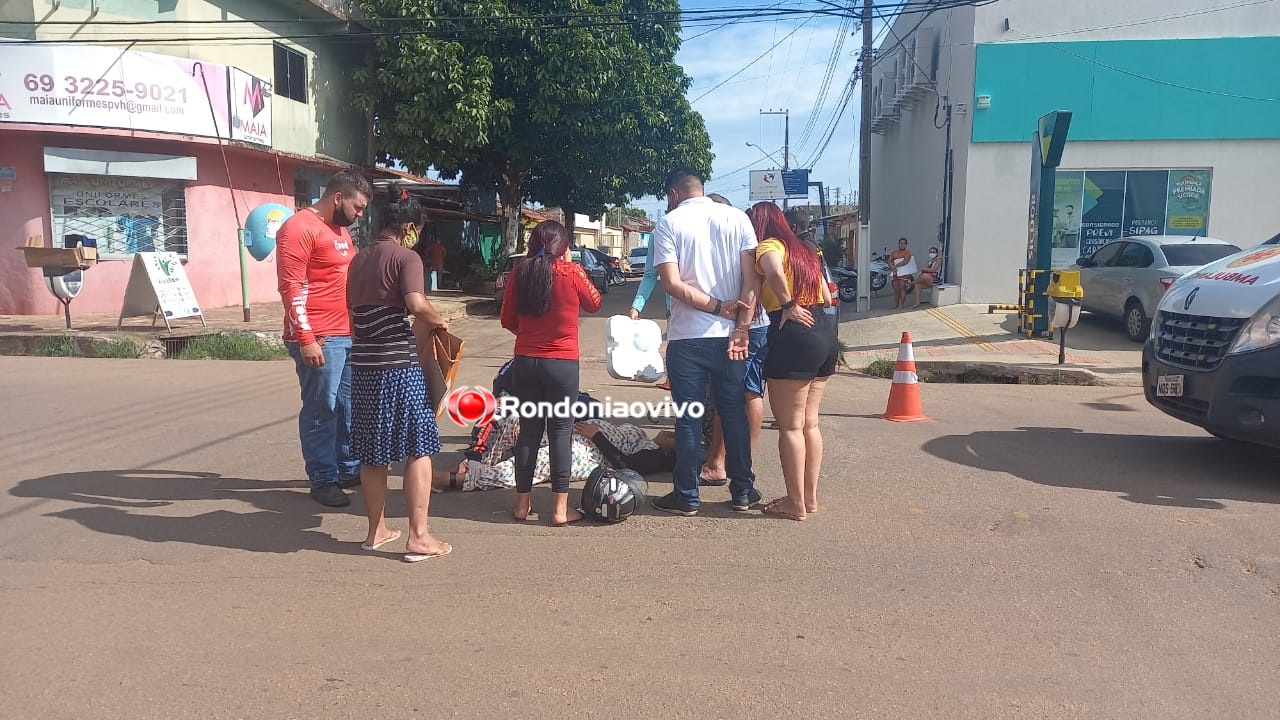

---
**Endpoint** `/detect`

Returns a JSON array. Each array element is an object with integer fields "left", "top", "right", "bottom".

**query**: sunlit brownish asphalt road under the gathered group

[{"left": 0, "top": 282, "right": 1280, "bottom": 720}]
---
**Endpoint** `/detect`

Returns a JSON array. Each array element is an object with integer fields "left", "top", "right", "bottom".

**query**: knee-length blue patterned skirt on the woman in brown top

[{"left": 351, "top": 365, "right": 440, "bottom": 466}]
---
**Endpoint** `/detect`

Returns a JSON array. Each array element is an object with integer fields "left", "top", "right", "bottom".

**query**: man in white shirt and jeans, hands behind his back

[{"left": 653, "top": 168, "right": 760, "bottom": 516}]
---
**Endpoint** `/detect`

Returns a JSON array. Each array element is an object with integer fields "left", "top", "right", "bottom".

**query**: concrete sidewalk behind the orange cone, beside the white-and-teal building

[{"left": 840, "top": 295, "right": 1142, "bottom": 387}]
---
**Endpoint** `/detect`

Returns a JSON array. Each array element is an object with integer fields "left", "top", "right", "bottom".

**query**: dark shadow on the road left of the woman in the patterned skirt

[{"left": 10, "top": 469, "right": 373, "bottom": 555}]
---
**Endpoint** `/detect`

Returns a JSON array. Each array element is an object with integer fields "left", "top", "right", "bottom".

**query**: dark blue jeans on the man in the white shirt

[{"left": 667, "top": 337, "right": 755, "bottom": 510}]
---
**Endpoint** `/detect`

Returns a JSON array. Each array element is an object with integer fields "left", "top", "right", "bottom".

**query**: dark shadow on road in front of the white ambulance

[{"left": 923, "top": 428, "right": 1280, "bottom": 510}]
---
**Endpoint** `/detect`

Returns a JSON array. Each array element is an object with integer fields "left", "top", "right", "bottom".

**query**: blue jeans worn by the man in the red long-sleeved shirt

[{"left": 284, "top": 336, "right": 360, "bottom": 488}]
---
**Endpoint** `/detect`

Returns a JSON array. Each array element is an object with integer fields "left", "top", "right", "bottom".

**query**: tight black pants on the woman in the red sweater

[{"left": 511, "top": 355, "right": 577, "bottom": 492}]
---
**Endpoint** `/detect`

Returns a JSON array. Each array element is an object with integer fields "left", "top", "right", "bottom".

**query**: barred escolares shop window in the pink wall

[{"left": 49, "top": 173, "right": 187, "bottom": 260}]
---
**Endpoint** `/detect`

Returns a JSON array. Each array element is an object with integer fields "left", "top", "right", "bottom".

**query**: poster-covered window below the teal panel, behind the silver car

[{"left": 1053, "top": 169, "right": 1213, "bottom": 260}]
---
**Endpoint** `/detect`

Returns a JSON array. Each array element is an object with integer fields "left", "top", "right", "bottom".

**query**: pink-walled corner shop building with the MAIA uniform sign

[{"left": 0, "top": 0, "right": 371, "bottom": 315}]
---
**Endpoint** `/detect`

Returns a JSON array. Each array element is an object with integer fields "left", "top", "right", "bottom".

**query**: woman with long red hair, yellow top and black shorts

[{"left": 750, "top": 202, "right": 838, "bottom": 520}]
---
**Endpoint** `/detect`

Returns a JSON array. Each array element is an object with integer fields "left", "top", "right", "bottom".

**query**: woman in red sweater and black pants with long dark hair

[{"left": 502, "top": 220, "right": 600, "bottom": 525}]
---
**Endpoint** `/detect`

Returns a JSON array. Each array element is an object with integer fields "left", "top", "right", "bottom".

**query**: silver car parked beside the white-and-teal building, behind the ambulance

[{"left": 1075, "top": 234, "right": 1240, "bottom": 342}]
